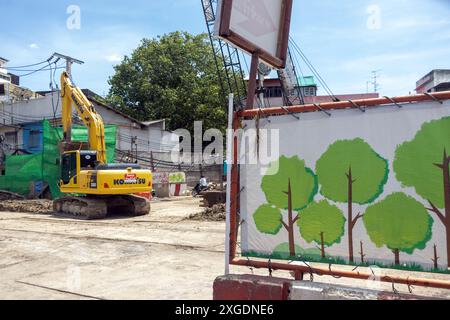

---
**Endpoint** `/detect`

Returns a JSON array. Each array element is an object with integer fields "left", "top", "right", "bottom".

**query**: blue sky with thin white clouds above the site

[{"left": 0, "top": 0, "right": 450, "bottom": 96}]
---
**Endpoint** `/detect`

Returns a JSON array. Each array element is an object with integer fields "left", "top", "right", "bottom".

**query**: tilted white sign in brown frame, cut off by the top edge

[{"left": 216, "top": 0, "right": 293, "bottom": 68}]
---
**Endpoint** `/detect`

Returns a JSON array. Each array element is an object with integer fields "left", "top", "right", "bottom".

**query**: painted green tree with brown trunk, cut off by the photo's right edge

[{"left": 394, "top": 117, "right": 450, "bottom": 267}]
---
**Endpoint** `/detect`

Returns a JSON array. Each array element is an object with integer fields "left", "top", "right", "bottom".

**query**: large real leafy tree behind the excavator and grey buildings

[{"left": 108, "top": 32, "right": 239, "bottom": 131}]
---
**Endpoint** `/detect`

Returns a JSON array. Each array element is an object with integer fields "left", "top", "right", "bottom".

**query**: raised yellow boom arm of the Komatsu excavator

[{"left": 61, "top": 72, "right": 106, "bottom": 164}]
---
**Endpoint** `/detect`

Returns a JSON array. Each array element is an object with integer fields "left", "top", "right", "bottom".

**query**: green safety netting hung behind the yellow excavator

[{"left": 0, "top": 120, "right": 117, "bottom": 198}]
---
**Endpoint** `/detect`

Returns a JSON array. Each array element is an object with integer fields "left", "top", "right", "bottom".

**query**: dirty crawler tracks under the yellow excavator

[{"left": 53, "top": 195, "right": 150, "bottom": 220}]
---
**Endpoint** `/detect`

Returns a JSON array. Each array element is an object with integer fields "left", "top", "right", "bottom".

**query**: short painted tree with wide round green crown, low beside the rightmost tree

[{"left": 363, "top": 192, "right": 433, "bottom": 265}]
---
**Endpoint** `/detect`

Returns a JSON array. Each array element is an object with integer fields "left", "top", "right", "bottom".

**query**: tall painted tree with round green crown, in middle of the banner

[{"left": 316, "top": 138, "right": 389, "bottom": 262}]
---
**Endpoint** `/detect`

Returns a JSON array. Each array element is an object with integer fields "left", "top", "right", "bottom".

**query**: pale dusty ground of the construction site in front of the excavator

[{"left": 0, "top": 197, "right": 450, "bottom": 300}]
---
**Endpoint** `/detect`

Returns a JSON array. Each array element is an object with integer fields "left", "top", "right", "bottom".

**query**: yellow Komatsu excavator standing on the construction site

[{"left": 53, "top": 72, "right": 152, "bottom": 219}]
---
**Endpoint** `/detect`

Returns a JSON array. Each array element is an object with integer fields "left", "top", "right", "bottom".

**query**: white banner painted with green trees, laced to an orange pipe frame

[{"left": 240, "top": 100, "right": 450, "bottom": 273}]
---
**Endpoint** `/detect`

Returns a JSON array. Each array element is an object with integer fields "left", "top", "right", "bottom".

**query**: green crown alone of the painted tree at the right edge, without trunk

[{"left": 394, "top": 117, "right": 450, "bottom": 209}]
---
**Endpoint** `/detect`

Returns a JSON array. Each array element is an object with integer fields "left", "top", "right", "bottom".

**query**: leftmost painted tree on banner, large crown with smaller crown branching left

[{"left": 253, "top": 156, "right": 318, "bottom": 257}]
